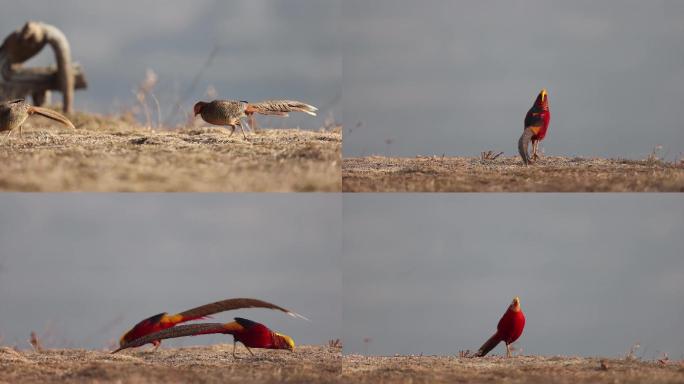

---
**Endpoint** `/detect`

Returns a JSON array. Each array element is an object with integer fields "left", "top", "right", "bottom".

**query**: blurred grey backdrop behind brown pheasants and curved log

[{"left": 0, "top": 0, "right": 342, "bottom": 128}]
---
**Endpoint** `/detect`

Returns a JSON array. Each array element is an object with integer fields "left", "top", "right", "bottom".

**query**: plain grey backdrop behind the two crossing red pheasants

[{"left": 0, "top": 194, "right": 342, "bottom": 349}]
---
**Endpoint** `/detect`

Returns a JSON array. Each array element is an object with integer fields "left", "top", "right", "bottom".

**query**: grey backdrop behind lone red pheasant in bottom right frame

[{"left": 342, "top": 194, "right": 684, "bottom": 359}]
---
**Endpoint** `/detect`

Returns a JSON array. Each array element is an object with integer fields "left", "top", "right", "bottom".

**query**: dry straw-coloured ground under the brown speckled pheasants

[{"left": 0, "top": 114, "right": 342, "bottom": 192}]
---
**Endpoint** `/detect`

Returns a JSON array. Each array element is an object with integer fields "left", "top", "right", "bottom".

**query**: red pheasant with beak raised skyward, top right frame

[{"left": 518, "top": 89, "right": 551, "bottom": 165}]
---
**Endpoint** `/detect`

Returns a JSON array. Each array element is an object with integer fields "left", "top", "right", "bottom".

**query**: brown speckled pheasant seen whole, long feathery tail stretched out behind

[{"left": 193, "top": 100, "right": 318, "bottom": 139}]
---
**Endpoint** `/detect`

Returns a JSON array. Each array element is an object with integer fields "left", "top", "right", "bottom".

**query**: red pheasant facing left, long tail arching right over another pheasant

[{"left": 119, "top": 298, "right": 306, "bottom": 347}]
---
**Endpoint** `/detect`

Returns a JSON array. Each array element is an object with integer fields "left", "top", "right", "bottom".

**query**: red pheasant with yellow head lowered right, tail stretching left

[{"left": 112, "top": 317, "right": 295, "bottom": 357}]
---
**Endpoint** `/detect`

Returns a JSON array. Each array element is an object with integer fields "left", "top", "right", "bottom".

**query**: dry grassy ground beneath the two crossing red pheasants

[{"left": 0, "top": 344, "right": 342, "bottom": 384}]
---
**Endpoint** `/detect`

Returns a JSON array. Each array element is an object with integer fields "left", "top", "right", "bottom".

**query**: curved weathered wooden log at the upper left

[{"left": 0, "top": 21, "right": 87, "bottom": 113}]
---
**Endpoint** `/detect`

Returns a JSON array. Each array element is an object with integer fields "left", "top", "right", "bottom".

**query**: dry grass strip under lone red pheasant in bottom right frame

[{"left": 342, "top": 355, "right": 684, "bottom": 384}]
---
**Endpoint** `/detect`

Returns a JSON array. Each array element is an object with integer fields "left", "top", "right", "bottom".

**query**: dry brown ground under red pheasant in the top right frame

[{"left": 342, "top": 156, "right": 684, "bottom": 192}]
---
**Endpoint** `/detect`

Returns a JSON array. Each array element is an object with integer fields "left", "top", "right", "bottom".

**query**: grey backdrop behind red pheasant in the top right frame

[{"left": 342, "top": 0, "right": 684, "bottom": 161}]
